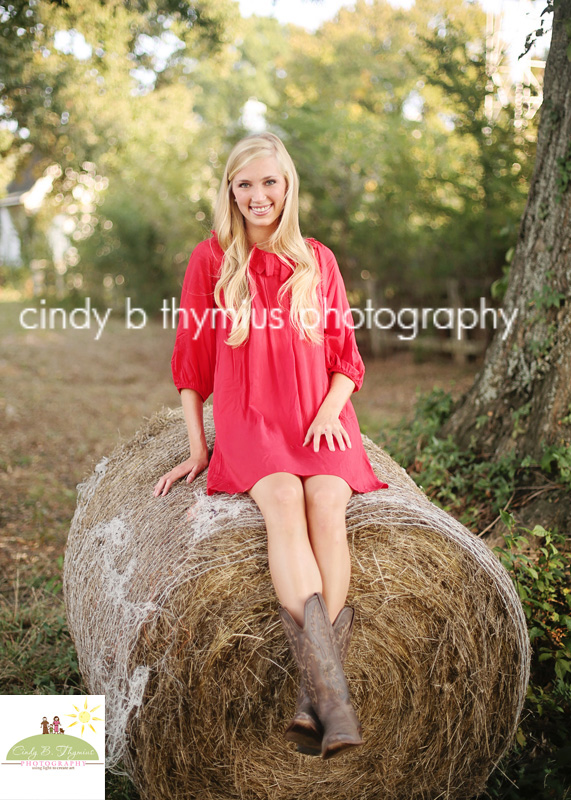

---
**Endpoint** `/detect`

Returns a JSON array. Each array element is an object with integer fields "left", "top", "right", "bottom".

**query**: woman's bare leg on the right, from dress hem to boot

[{"left": 302, "top": 475, "right": 353, "bottom": 622}]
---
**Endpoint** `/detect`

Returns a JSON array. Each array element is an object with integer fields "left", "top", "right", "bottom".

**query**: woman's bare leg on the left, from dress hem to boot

[{"left": 248, "top": 472, "right": 323, "bottom": 625}]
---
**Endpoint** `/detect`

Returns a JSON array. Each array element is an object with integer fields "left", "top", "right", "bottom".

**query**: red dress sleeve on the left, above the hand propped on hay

[{"left": 171, "top": 240, "right": 216, "bottom": 401}]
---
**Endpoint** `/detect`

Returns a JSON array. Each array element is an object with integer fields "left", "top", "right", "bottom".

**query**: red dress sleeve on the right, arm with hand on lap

[{"left": 321, "top": 247, "right": 365, "bottom": 392}]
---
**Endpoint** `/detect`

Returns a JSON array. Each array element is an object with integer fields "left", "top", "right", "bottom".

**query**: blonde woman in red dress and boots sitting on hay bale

[{"left": 154, "top": 133, "right": 387, "bottom": 758}]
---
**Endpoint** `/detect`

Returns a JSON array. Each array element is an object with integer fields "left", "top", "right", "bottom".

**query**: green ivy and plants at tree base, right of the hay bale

[{"left": 386, "top": 389, "right": 571, "bottom": 800}]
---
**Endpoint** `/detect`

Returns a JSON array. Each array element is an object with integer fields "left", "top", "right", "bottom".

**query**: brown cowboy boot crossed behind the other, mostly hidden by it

[{"left": 284, "top": 606, "right": 355, "bottom": 756}]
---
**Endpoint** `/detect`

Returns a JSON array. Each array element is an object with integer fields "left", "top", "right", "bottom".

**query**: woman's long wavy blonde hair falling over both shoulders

[{"left": 214, "top": 133, "right": 323, "bottom": 347}]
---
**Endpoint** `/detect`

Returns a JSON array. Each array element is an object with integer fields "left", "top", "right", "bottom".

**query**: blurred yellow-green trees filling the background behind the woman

[{"left": 0, "top": 0, "right": 537, "bottom": 311}]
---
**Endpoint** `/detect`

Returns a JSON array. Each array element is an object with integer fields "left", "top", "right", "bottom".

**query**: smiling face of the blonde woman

[{"left": 232, "top": 156, "right": 287, "bottom": 245}]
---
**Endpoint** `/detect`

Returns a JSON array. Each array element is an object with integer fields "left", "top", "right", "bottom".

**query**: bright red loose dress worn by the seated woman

[{"left": 172, "top": 232, "right": 388, "bottom": 495}]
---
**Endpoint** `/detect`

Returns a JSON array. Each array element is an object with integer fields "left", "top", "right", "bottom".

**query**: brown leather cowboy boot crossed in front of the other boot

[{"left": 280, "top": 592, "right": 363, "bottom": 758}]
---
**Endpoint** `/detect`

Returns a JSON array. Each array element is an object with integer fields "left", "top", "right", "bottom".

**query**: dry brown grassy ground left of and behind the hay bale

[{"left": 0, "top": 296, "right": 477, "bottom": 800}]
